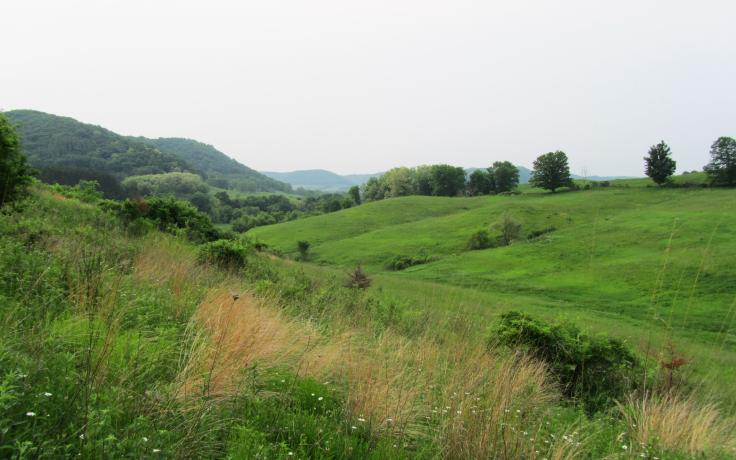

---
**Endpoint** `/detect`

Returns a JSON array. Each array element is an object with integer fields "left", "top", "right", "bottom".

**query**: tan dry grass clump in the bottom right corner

[{"left": 619, "top": 394, "right": 736, "bottom": 455}]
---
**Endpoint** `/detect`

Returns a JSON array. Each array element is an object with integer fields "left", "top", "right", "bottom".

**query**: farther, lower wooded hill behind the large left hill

[{"left": 132, "top": 137, "right": 292, "bottom": 192}]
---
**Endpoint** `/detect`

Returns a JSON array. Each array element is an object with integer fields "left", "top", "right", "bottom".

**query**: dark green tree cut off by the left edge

[{"left": 0, "top": 113, "right": 31, "bottom": 206}]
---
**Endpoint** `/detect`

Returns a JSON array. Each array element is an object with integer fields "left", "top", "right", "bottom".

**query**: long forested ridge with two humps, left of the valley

[{"left": 5, "top": 110, "right": 291, "bottom": 192}]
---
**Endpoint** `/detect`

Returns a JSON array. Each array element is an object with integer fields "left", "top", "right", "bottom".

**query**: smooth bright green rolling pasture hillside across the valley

[{"left": 252, "top": 181, "right": 736, "bottom": 410}]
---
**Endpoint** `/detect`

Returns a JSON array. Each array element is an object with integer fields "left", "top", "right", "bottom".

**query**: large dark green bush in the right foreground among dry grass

[{"left": 489, "top": 312, "right": 643, "bottom": 412}]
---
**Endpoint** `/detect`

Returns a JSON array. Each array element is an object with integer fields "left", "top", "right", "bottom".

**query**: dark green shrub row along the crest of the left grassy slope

[{"left": 118, "top": 197, "right": 220, "bottom": 243}]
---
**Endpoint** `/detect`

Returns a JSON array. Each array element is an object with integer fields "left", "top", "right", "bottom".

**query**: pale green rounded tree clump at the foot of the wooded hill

[{"left": 121, "top": 172, "right": 209, "bottom": 198}]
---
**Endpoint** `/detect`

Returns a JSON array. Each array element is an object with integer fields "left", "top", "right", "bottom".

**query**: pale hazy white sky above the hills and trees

[{"left": 0, "top": 0, "right": 736, "bottom": 176}]
